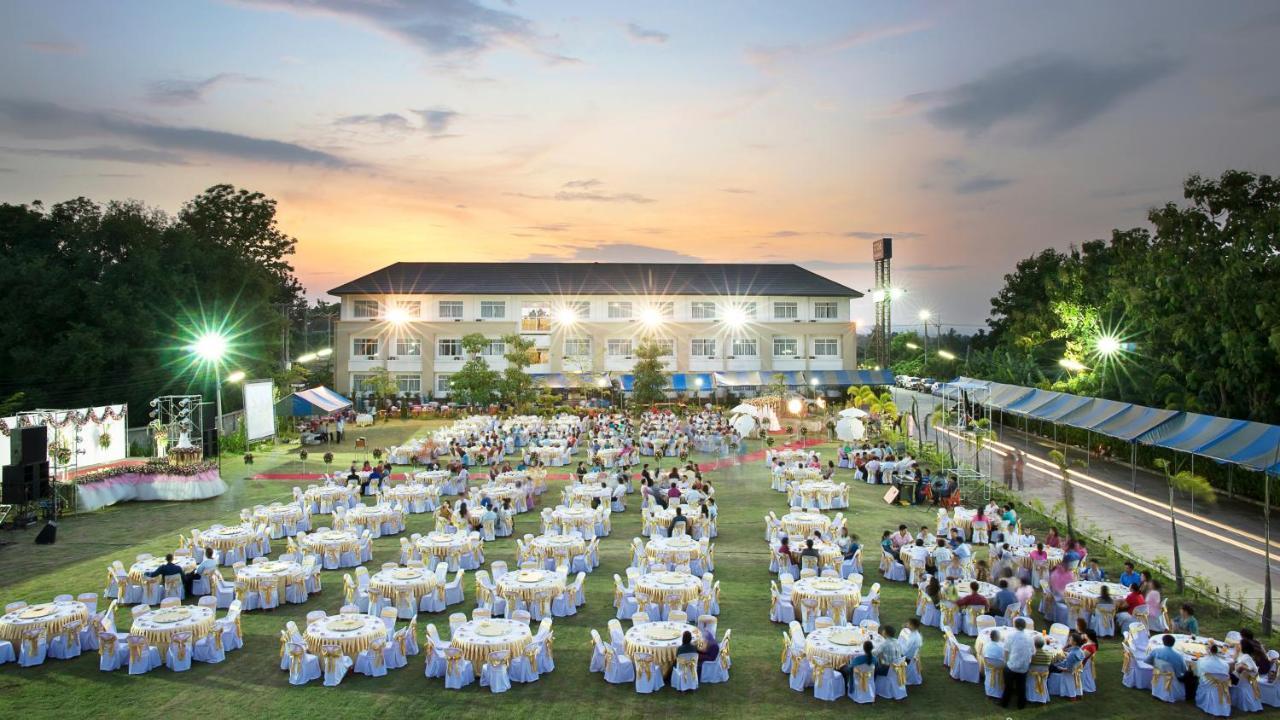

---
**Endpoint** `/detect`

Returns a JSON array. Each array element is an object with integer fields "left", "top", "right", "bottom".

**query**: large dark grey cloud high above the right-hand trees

[{"left": 908, "top": 54, "right": 1181, "bottom": 138}]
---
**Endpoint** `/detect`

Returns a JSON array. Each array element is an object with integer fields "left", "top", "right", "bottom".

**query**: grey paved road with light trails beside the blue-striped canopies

[{"left": 895, "top": 389, "right": 1280, "bottom": 618}]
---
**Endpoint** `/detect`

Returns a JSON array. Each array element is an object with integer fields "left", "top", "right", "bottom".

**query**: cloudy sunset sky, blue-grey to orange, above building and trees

[{"left": 0, "top": 0, "right": 1280, "bottom": 331}]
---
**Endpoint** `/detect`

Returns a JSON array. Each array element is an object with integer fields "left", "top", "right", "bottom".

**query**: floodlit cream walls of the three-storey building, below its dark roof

[{"left": 334, "top": 288, "right": 858, "bottom": 397}]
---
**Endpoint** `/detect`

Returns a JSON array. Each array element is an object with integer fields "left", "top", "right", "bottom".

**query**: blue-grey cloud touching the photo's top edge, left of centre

[{"left": 242, "top": 0, "right": 541, "bottom": 58}]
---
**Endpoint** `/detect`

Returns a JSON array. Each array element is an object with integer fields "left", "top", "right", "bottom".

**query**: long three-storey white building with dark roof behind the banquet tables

[{"left": 330, "top": 263, "right": 861, "bottom": 398}]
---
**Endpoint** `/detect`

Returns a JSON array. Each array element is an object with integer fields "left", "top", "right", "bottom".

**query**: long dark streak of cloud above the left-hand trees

[{"left": 0, "top": 99, "right": 355, "bottom": 168}]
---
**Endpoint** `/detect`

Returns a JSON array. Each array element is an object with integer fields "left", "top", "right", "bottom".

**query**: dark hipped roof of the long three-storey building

[{"left": 329, "top": 263, "right": 863, "bottom": 297}]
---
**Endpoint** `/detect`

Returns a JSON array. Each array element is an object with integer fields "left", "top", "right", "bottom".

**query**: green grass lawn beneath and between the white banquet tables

[{"left": 0, "top": 421, "right": 1259, "bottom": 720}]
